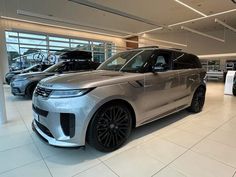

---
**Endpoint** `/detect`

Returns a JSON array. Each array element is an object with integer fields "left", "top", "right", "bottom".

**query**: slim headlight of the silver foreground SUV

[{"left": 50, "top": 88, "right": 94, "bottom": 98}]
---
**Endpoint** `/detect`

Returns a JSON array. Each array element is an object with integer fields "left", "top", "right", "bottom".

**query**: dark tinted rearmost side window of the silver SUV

[{"left": 173, "top": 52, "right": 201, "bottom": 70}]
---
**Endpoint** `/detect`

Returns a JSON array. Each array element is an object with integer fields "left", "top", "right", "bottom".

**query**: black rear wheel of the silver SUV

[{"left": 187, "top": 87, "right": 206, "bottom": 113}]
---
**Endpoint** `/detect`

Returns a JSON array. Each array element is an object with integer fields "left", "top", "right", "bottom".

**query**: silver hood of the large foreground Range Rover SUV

[{"left": 40, "top": 70, "right": 143, "bottom": 89}]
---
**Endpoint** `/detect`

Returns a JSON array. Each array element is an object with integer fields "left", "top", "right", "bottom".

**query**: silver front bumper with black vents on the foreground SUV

[{"left": 32, "top": 94, "right": 100, "bottom": 147}]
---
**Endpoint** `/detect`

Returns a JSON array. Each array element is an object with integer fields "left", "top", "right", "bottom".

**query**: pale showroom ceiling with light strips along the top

[{"left": 0, "top": 0, "right": 236, "bottom": 37}]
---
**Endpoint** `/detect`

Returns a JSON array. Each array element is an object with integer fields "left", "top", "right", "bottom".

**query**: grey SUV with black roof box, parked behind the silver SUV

[{"left": 11, "top": 51, "right": 100, "bottom": 97}]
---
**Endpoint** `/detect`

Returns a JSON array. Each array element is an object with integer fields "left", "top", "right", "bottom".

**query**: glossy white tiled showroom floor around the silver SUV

[{"left": 0, "top": 83, "right": 236, "bottom": 177}]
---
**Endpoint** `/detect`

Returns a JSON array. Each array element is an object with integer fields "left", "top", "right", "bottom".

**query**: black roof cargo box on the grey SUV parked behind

[{"left": 60, "top": 50, "right": 92, "bottom": 60}]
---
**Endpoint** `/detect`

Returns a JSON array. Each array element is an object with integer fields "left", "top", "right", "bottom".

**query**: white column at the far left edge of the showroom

[{"left": 0, "top": 21, "right": 8, "bottom": 124}]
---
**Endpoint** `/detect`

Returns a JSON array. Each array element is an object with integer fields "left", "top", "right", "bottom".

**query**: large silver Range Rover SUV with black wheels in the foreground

[{"left": 32, "top": 47, "right": 206, "bottom": 152}]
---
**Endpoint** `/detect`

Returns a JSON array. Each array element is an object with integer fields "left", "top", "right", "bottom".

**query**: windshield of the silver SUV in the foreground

[{"left": 98, "top": 50, "right": 153, "bottom": 72}]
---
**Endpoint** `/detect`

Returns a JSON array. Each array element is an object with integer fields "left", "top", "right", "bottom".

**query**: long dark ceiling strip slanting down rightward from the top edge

[{"left": 69, "top": 0, "right": 161, "bottom": 26}]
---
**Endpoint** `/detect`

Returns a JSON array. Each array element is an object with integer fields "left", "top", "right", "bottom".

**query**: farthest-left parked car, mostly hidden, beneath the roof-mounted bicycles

[{"left": 5, "top": 63, "right": 52, "bottom": 85}]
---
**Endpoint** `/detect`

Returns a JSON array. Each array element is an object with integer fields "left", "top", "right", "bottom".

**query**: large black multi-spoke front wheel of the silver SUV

[{"left": 87, "top": 103, "right": 132, "bottom": 152}]
